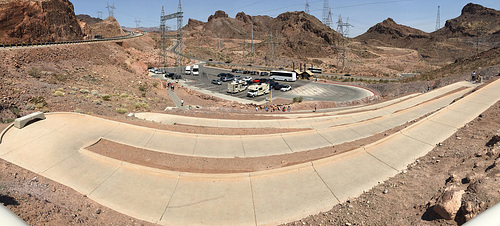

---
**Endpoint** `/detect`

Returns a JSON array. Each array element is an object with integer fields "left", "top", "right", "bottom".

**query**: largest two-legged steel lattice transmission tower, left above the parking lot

[{"left": 159, "top": 0, "right": 184, "bottom": 71}]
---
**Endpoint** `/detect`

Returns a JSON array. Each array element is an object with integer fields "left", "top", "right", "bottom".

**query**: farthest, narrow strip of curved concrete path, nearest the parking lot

[{"left": 135, "top": 82, "right": 477, "bottom": 129}]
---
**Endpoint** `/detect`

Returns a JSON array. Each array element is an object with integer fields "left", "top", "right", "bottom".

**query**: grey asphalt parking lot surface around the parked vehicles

[{"left": 162, "top": 66, "right": 373, "bottom": 102}]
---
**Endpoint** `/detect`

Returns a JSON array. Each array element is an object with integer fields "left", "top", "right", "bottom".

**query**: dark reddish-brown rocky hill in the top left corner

[{"left": 0, "top": 0, "right": 83, "bottom": 44}]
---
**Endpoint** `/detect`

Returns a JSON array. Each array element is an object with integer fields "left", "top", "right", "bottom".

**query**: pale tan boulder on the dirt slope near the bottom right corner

[{"left": 433, "top": 187, "right": 465, "bottom": 220}]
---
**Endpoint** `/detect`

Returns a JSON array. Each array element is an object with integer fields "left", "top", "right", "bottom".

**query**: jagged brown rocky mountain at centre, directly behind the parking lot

[{"left": 184, "top": 11, "right": 340, "bottom": 57}]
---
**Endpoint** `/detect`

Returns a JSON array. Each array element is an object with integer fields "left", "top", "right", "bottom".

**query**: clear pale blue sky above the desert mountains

[{"left": 70, "top": 0, "right": 500, "bottom": 37}]
